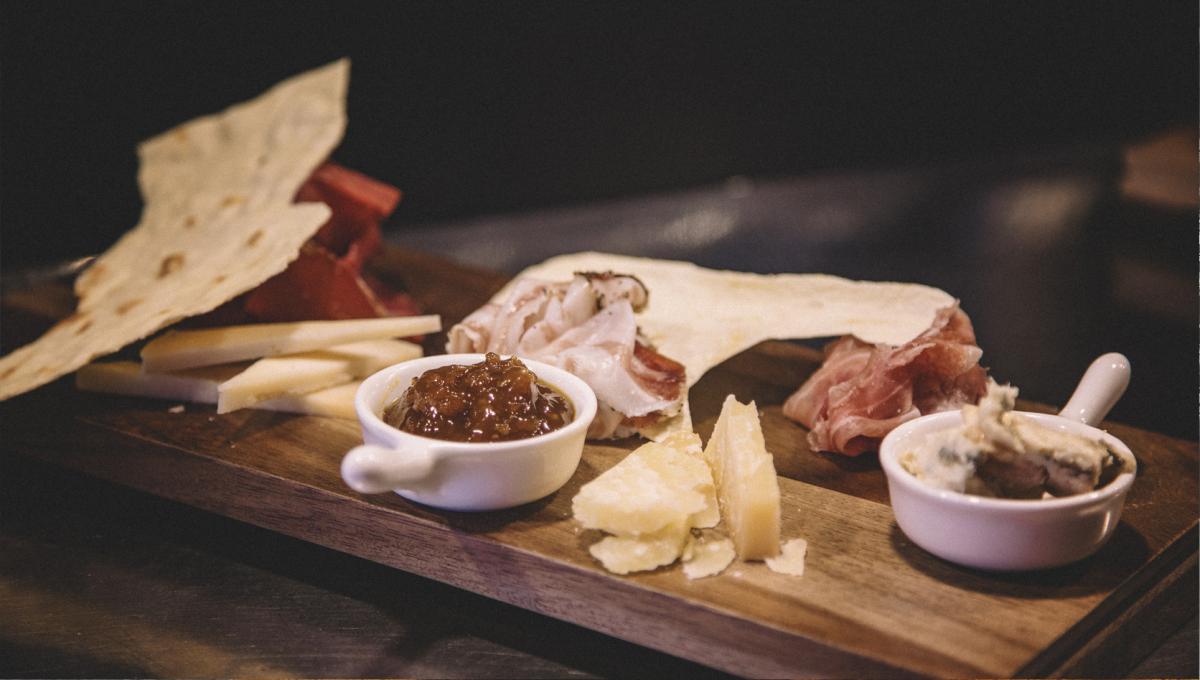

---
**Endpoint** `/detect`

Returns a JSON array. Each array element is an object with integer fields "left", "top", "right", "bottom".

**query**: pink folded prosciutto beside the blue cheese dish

[{"left": 784, "top": 302, "right": 988, "bottom": 456}]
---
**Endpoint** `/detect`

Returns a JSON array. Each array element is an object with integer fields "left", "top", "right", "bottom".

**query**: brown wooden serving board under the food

[{"left": 0, "top": 251, "right": 1200, "bottom": 676}]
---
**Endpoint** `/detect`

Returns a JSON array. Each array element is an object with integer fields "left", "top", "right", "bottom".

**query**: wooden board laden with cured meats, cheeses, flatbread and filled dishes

[{"left": 0, "top": 62, "right": 1200, "bottom": 676}]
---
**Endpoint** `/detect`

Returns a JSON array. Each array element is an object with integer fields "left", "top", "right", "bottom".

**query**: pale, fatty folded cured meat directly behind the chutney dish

[{"left": 446, "top": 272, "right": 686, "bottom": 439}]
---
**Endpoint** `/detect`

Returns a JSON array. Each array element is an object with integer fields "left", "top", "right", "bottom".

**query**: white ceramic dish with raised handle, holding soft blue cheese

[{"left": 880, "top": 354, "right": 1136, "bottom": 571}]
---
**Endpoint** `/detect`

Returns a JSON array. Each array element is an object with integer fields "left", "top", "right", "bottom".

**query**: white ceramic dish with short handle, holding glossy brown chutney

[{"left": 342, "top": 354, "right": 596, "bottom": 511}]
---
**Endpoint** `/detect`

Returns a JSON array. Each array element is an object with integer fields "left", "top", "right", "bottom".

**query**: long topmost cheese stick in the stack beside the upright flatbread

[{"left": 142, "top": 314, "right": 442, "bottom": 373}]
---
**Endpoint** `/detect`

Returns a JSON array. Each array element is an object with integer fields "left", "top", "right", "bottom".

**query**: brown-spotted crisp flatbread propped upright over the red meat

[{"left": 0, "top": 59, "right": 349, "bottom": 399}]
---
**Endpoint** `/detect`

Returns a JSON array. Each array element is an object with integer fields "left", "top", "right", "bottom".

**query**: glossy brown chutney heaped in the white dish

[{"left": 383, "top": 353, "right": 575, "bottom": 441}]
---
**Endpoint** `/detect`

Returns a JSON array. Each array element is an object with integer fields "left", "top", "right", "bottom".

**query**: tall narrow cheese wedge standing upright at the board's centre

[{"left": 704, "top": 395, "right": 780, "bottom": 560}]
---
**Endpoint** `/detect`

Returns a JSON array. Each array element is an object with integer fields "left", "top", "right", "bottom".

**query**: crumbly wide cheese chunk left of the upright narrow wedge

[{"left": 571, "top": 434, "right": 714, "bottom": 536}]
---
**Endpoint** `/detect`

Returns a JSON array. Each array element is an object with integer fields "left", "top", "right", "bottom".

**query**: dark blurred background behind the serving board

[{"left": 0, "top": 1, "right": 1200, "bottom": 439}]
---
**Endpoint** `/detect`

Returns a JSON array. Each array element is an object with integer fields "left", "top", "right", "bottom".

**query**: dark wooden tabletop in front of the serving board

[{"left": 0, "top": 456, "right": 726, "bottom": 680}]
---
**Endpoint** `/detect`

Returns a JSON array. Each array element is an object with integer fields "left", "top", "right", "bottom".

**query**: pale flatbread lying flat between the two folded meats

[{"left": 508, "top": 252, "right": 954, "bottom": 386}]
